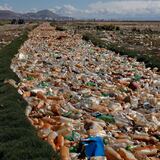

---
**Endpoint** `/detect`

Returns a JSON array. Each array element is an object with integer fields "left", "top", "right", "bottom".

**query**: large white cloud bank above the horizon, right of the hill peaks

[{"left": 49, "top": 0, "right": 160, "bottom": 19}]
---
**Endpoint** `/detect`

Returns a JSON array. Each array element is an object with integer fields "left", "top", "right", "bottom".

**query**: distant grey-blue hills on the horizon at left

[{"left": 0, "top": 10, "right": 73, "bottom": 20}]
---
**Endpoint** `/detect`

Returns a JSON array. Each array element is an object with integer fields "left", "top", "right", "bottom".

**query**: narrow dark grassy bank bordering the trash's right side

[{"left": 83, "top": 33, "right": 160, "bottom": 70}]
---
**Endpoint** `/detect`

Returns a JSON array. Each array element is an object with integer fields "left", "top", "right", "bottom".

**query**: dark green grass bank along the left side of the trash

[{"left": 0, "top": 33, "right": 59, "bottom": 160}]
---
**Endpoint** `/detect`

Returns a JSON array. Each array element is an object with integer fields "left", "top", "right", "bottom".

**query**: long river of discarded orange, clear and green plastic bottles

[{"left": 11, "top": 23, "right": 160, "bottom": 160}]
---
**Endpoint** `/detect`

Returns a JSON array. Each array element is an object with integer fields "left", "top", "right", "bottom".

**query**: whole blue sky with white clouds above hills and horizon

[{"left": 0, "top": 0, "right": 160, "bottom": 20}]
